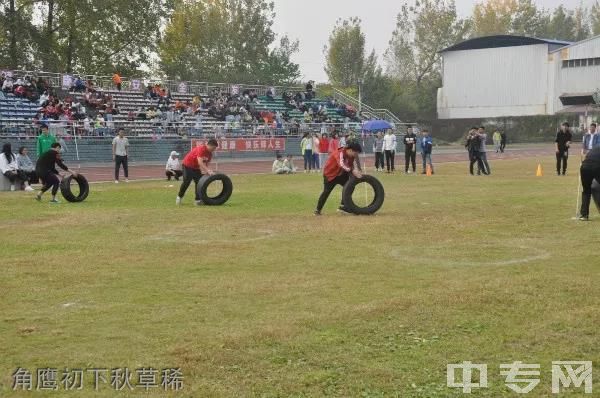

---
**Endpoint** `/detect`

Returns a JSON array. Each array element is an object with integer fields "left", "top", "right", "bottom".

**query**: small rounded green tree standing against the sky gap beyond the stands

[{"left": 324, "top": 18, "right": 376, "bottom": 87}]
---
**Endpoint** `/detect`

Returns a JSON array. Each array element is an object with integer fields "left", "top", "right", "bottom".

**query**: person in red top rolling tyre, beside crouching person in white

[{"left": 175, "top": 138, "right": 219, "bottom": 206}]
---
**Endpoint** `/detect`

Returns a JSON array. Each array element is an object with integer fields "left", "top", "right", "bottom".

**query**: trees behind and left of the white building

[{"left": 324, "top": 0, "right": 600, "bottom": 121}]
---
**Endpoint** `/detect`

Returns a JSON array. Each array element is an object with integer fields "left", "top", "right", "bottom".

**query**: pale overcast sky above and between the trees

[{"left": 273, "top": 0, "right": 594, "bottom": 82}]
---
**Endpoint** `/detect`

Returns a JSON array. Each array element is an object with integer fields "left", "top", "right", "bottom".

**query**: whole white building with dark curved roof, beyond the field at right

[{"left": 437, "top": 36, "right": 600, "bottom": 119}]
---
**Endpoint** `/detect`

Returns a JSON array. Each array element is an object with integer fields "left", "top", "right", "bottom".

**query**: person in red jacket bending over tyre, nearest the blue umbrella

[{"left": 315, "top": 141, "right": 362, "bottom": 216}]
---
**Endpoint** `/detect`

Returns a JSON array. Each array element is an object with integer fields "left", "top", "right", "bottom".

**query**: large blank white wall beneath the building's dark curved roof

[{"left": 438, "top": 44, "right": 549, "bottom": 119}]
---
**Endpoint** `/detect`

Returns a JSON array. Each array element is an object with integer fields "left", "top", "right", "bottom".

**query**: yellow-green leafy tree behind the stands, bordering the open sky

[{"left": 159, "top": 0, "right": 300, "bottom": 84}]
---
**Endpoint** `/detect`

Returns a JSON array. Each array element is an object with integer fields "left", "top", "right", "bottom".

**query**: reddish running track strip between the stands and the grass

[{"left": 77, "top": 145, "right": 554, "bottom": 182}]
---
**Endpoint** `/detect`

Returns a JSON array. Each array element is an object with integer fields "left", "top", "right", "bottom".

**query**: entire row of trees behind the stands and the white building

[{"left": 0, "top": 0, "right": 600, "bottom": 120}]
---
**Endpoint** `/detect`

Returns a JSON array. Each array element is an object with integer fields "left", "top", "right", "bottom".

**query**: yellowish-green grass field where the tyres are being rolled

[{"left": 0, "top": 158, "right": 600, "bottom": 397}]
